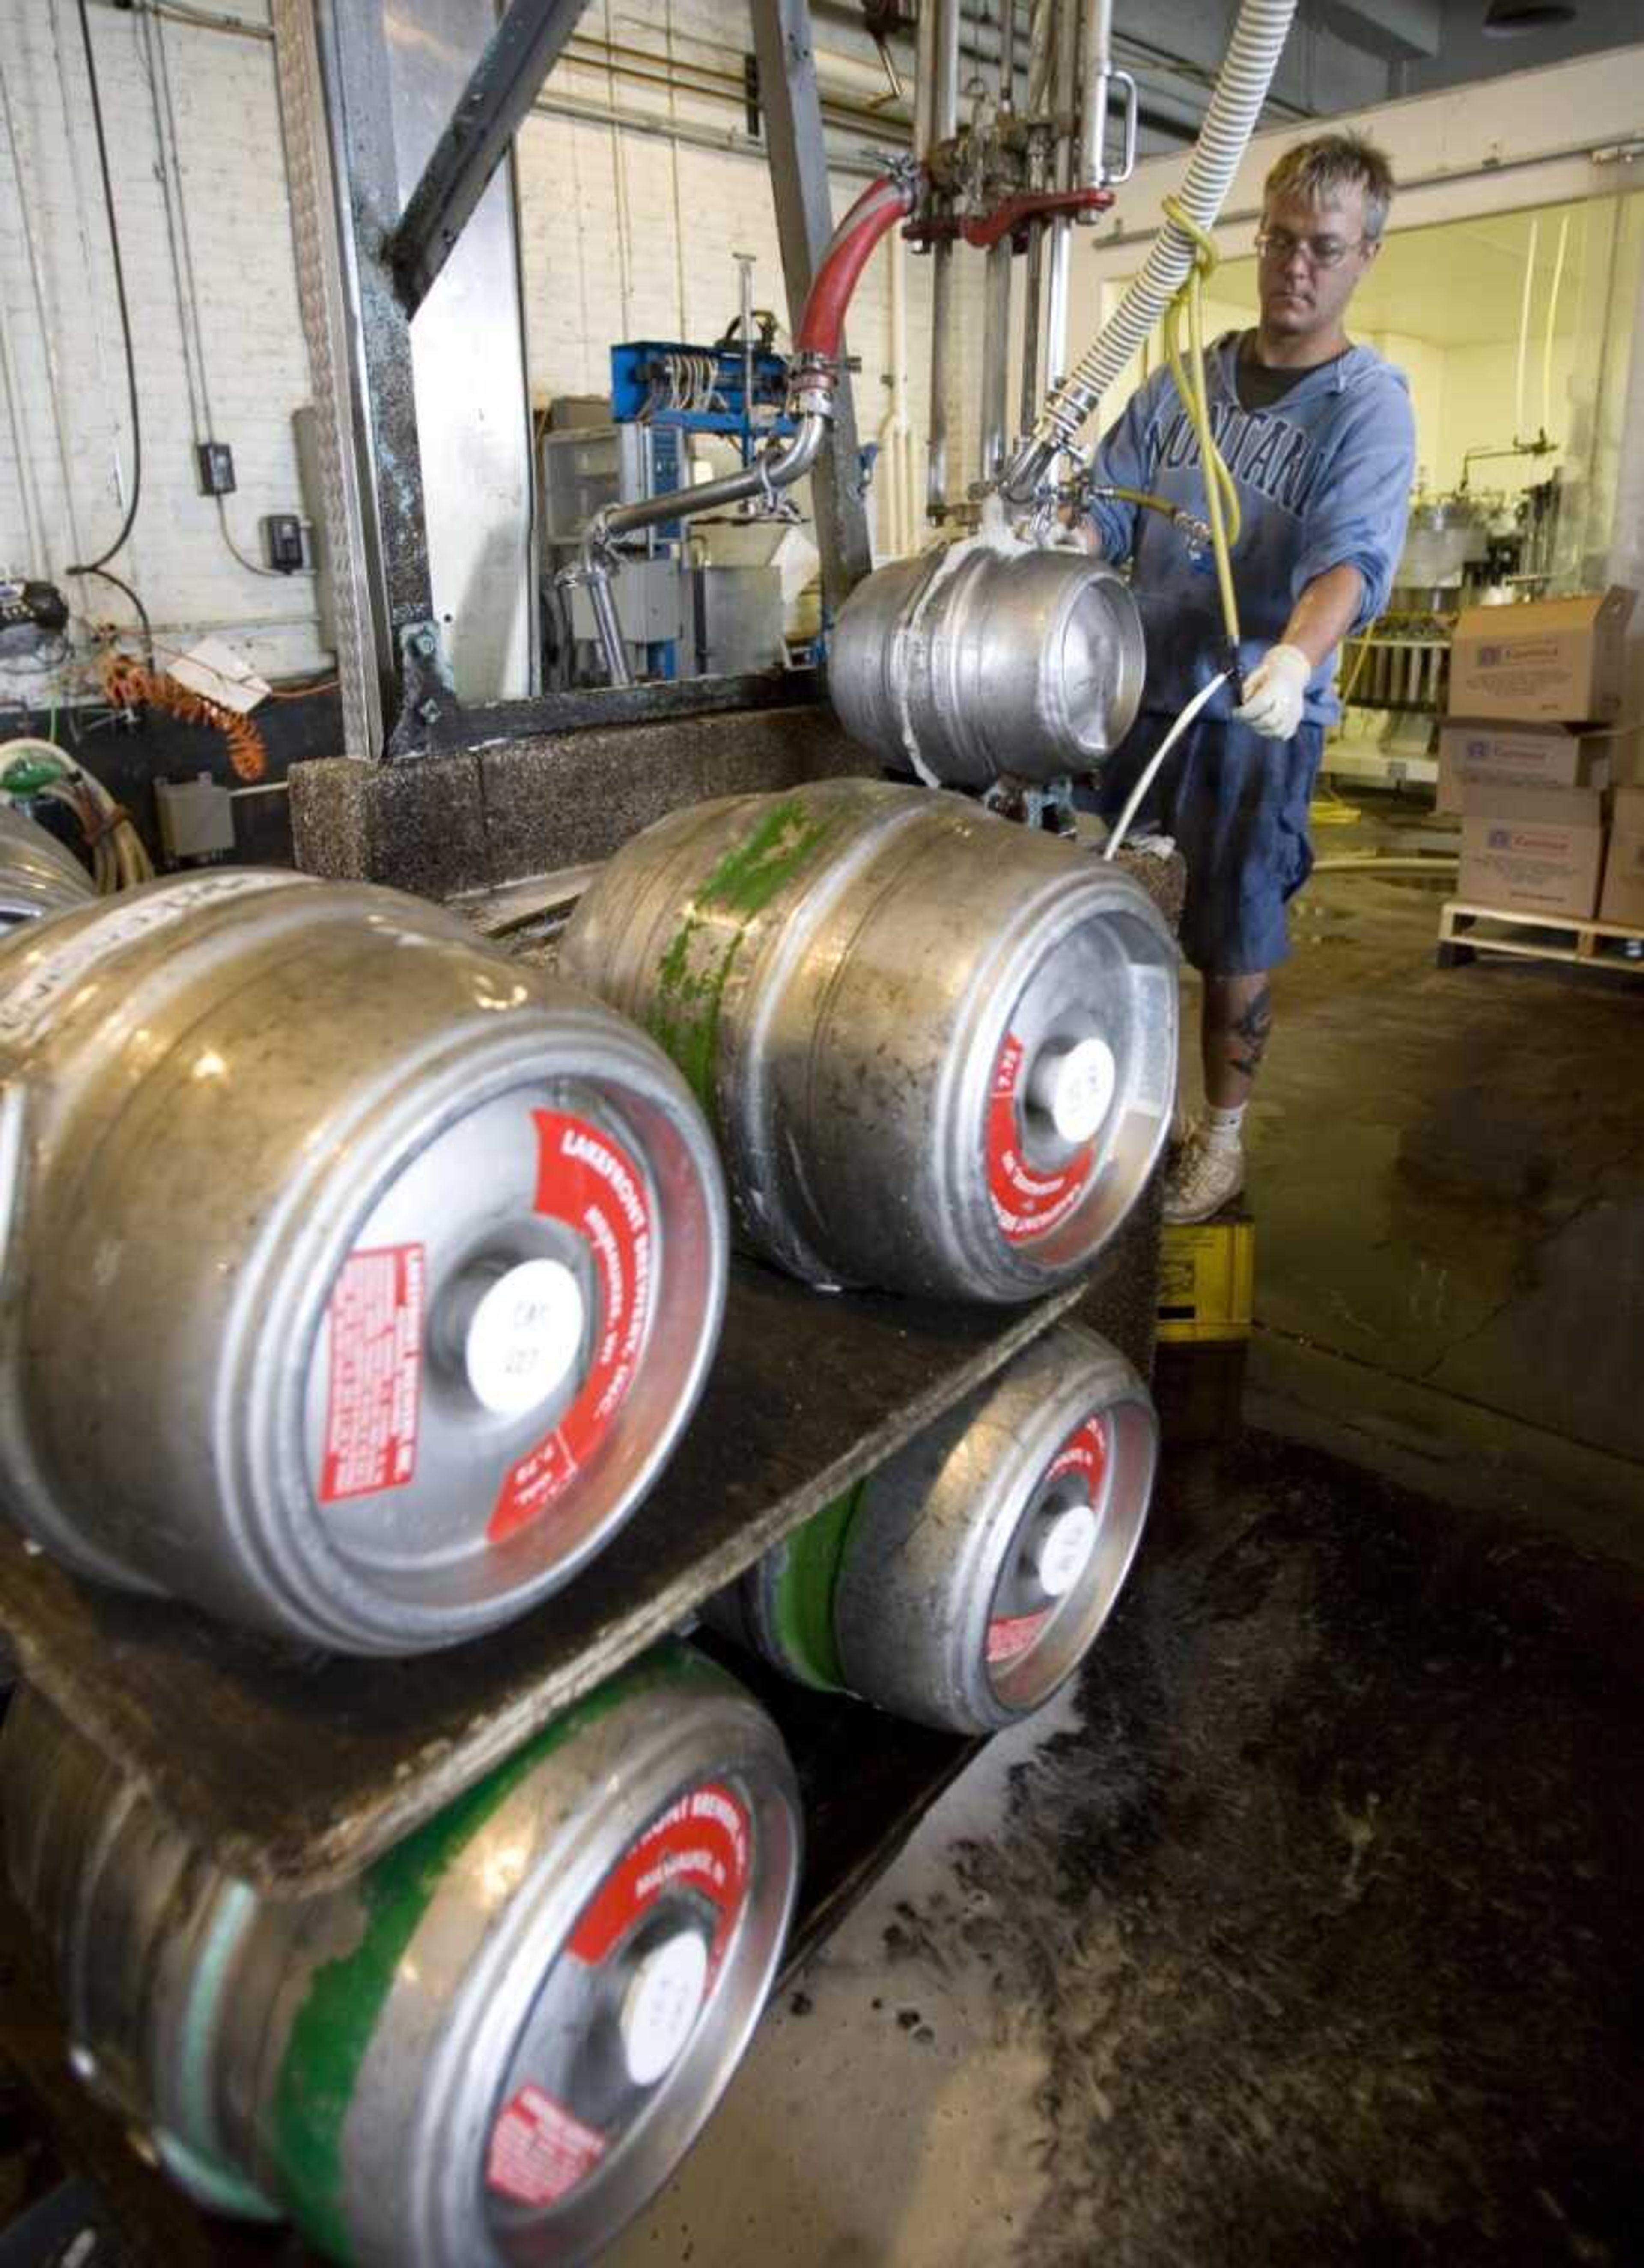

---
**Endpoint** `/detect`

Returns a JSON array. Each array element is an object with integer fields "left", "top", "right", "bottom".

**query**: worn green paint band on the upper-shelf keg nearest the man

[{"left": 649, "top": 796, "right": 834, "bottom": 1118}]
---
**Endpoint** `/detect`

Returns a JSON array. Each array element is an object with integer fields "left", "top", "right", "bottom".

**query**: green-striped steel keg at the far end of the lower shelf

[{"left": 708, "top": 1324, "right": 1159, "bottom": 1733}]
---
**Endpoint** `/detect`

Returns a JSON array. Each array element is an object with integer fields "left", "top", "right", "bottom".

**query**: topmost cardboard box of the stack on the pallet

[{"left": 1449, "top": 583, "right": 1635, "bottom": 724}]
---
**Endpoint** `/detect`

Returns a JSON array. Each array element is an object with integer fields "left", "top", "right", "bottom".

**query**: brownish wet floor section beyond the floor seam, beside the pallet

[{"left": 1252, "top": 812, "right": 1644, "bottom": 1460}]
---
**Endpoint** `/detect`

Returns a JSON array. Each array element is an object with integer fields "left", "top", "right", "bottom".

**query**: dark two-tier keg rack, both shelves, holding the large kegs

[{"left": 0, "top": 1202, "right": 1159, "bottom": 2268}]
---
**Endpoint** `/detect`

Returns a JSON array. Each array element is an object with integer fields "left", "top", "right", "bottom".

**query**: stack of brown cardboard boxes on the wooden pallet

[{"left": 1438, "top": 585, "right": 1644, "bottom": 927}]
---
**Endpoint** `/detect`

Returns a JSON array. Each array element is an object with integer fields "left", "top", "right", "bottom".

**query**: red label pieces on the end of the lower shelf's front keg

[{"left": 485, "top": 1782, "right": 753, "bottom": 2205}]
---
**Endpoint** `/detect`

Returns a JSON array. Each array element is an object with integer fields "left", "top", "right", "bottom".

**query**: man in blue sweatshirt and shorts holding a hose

[{"left": 1091, "top": 134, "right": 1415, "bottom": 1220}]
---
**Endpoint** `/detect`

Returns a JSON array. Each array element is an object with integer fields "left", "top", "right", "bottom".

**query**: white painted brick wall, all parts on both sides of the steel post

[{"left": 0, "top": 0, "right": 982, "bottom": 698}]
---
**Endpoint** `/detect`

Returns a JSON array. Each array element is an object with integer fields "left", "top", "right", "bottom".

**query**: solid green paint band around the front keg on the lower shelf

[{"left": 272, "top": 1644, "right": 724, "bottom": 2261}]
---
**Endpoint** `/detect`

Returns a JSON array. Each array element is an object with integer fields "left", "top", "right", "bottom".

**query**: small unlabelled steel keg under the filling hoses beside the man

[{"left": 828, "top": 542, "right": 1145, "bottom": 787}]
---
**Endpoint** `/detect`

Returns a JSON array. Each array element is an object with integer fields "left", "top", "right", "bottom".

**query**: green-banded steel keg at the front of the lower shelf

[{"left": 0, "top": 1647, "right": 801, "bottom": 2268}]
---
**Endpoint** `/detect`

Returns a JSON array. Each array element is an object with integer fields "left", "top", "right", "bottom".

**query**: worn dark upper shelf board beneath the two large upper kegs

[{"left": 0, "top": 1261, "right": 1102, "bottom": 1898}]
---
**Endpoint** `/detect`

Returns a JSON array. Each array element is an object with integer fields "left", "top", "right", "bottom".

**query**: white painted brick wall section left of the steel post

[{"left": 0, "top": 0, "right": 324, "bottom": 698}]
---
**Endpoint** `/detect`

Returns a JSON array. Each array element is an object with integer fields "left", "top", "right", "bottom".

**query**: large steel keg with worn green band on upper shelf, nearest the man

[{"left": 560, "top": 780, "right": 1177, "bottom": 1299}]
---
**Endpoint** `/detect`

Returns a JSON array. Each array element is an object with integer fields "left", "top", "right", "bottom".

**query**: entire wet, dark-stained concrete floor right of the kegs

[{"left": 617, "top": 808, "right": 1644, "bottom": 2268}]
